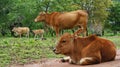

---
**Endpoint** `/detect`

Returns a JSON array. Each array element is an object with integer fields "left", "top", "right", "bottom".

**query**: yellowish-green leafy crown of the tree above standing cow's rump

[{"left": 80, "top": 0, "right": 112, "bottom": 22}]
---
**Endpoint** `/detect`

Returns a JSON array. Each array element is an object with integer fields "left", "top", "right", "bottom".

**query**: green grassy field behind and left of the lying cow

[{"left": 0, "top": 36, "right": 120, "bottom": 67}]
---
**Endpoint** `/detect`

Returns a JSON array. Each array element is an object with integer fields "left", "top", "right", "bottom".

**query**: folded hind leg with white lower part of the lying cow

[{"left": 79, "top": 44, "right": 102, "bottom": 65}]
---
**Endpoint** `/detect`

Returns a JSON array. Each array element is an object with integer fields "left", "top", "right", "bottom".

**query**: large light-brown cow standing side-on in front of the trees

[{"left": 35, "top": 10, "right": 88, "bottom": 36}]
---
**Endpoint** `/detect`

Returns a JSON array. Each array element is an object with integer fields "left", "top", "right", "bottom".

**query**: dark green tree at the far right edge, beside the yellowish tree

[{"left": 108, "top": 1, "right": 120, "bottom": 35}]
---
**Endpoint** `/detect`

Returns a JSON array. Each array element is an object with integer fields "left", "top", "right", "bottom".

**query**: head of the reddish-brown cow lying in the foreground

[{"left": 53, "top": 33, "right": 74, "bottom": 55}]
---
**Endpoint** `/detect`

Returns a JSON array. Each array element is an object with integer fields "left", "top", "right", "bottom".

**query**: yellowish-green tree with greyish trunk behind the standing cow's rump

[{"left": 80, "top": 0, "right": 112, "bottom": 35}]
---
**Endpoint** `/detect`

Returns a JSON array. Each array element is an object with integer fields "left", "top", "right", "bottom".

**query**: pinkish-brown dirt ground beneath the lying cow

[{"left": 10, "top": 50, "right": 120, "bottom": 67}]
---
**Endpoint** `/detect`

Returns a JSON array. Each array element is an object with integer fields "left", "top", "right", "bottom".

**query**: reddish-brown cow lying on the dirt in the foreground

[{"left": 53, "top": 33, "right": 116, "bottom": 65}]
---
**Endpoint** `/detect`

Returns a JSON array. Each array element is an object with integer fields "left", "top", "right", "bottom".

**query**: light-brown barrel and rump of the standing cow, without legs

[{"left": 55, "top": 10, "right": 88, "bottom": 29}]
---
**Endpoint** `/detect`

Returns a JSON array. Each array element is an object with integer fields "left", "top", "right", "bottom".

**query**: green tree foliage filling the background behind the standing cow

[{"left": 0, "top": 0, "right": 120, "bottom": 36}]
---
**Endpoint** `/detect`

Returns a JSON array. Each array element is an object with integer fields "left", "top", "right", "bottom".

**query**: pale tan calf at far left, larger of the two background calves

[{"left": 12, "top": 27, "right": 30, "bottom": 38}]
